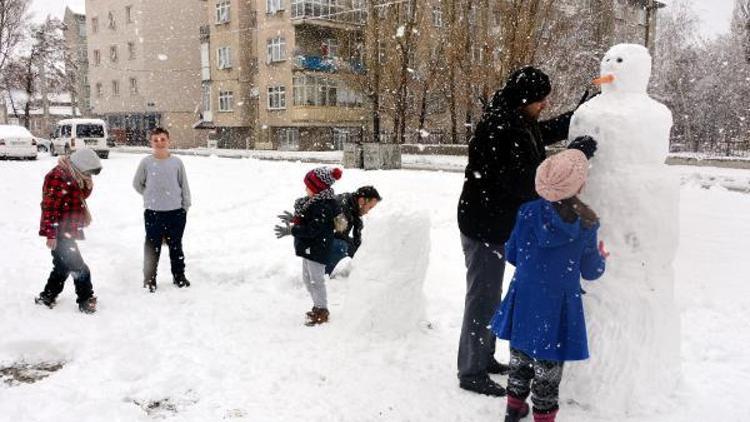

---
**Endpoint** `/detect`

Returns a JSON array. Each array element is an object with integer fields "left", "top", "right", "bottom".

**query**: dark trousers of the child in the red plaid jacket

[{"left": 42, "top": 239, "right": 94, "bottom": 303}]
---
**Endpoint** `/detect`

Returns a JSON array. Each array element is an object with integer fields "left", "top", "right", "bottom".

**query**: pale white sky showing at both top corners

[{"left": 32, "top": 0, "right": 734, "bottom": 37}]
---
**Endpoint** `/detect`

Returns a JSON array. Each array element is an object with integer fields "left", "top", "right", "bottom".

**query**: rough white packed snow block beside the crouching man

[{"left": 337, "top": 211, "right": 430, "bottom": 339}]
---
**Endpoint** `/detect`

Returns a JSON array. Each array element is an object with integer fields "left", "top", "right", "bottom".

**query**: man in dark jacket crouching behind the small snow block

[{"left": 326, "top": 186, "right": 383, "bottom": 274}]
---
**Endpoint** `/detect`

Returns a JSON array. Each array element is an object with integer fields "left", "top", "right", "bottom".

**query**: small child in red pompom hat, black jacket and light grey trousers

[{"left": 277, "top": 167, "right": 341, "bottom": 327}]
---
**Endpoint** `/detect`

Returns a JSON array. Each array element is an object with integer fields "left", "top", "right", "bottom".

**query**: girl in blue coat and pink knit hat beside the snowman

[{"left": 491, "top": 149, "right": 608, "bottom": 422}]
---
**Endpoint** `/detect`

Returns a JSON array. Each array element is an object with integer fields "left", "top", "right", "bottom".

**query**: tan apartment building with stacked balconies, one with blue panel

[{"left": 196, "top": 0, "right": 367, "bottom": 150}]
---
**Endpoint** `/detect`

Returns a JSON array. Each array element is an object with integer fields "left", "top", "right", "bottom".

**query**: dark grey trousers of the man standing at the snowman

[{"left": 458, "top": 234, "right": 505, "bottom": 379}]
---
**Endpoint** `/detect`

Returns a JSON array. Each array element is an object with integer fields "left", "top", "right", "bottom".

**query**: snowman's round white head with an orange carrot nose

[{"left": 594, "top": 44, "right": 651, "bottom": 94}]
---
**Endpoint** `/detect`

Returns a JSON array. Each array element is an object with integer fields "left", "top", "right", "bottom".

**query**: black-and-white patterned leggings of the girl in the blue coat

[{"left": 508, "top": 348, "right": 563, "bottom": 413}]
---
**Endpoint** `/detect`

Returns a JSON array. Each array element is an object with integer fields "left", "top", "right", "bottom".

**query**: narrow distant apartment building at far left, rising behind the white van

[{"left": 63, "top": 7, "right": 91, "bottom": 116}]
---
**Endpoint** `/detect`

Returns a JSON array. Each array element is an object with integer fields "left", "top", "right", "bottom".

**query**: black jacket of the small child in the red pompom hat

[{"left": 292, "top": 199, "right": 341, "bottom": 264}]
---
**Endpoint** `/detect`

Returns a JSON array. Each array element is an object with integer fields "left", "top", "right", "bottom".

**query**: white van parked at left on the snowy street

[{"left": 50, "top": 119, "right": 109, "bottom": 158}]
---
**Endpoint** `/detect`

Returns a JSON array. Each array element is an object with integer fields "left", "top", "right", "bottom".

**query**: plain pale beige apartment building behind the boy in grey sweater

[{"left": 86, "top": 0, "right": 207, "bottom": 147}]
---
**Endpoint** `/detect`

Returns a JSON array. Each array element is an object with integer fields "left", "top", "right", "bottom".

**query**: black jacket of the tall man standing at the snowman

[{"left": 458, "top": 95, "right": 573, "bottom": 244}]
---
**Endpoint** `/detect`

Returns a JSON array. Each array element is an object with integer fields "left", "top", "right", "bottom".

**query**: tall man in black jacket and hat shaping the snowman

[{"left": 458, "top": 66, "right": 596, "bottom": 396}]
